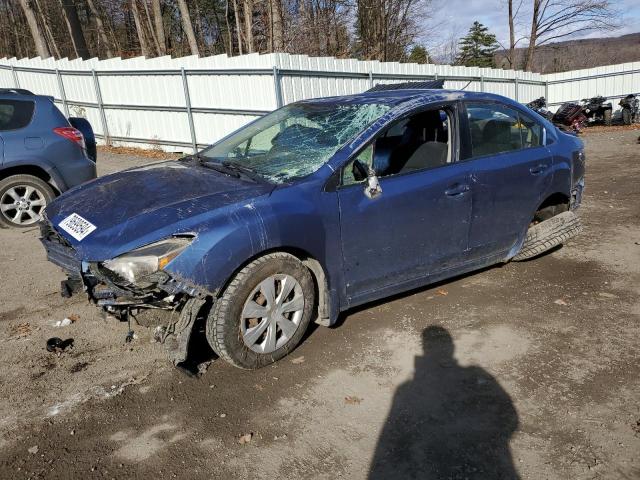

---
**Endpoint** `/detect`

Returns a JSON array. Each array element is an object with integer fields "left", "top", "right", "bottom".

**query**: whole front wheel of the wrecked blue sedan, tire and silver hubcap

[{"left": 207, "top": 252, "right": 315, "bottom": 369}]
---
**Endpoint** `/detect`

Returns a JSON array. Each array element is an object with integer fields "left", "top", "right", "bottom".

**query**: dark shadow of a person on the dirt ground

[{"left": 368, "top": 326, "right": 519, "bottom": 480}]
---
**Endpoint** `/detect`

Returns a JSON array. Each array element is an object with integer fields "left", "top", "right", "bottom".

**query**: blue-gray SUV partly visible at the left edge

[{"left": 0, "top": 89, "right": 96, "bottom": 228}]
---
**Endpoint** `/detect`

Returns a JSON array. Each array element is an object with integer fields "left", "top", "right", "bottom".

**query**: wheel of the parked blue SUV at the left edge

[{"left": 0, "top": 175, "right": 55, "bottom": 228}]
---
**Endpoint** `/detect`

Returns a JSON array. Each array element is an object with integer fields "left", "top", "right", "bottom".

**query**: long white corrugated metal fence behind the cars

[{"left": 0, "top": 53, "right": 640, "bottom": 151}]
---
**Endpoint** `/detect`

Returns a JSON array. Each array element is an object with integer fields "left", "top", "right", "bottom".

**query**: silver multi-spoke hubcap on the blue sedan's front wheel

[{"left": 240, "top": 274, "right": 304, "bottom": 353}]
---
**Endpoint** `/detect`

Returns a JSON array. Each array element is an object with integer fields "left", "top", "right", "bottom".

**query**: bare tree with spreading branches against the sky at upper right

[{"left": 524, "top": 0, "right": 617, "bottom": 70}]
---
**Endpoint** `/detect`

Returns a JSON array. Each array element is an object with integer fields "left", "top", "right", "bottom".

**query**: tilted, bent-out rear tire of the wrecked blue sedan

[{"left": 513, "top": 211, "right": 582, "bottom": 262}]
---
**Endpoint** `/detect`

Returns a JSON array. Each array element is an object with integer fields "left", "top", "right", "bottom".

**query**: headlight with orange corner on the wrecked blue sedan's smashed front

[{"left": 102, "top": 237, "right": 193, "bottom": 283}]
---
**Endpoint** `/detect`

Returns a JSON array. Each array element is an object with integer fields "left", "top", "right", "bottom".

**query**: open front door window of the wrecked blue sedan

[{"left": 342, "top": 109, "right": 453, "bottom": 185}]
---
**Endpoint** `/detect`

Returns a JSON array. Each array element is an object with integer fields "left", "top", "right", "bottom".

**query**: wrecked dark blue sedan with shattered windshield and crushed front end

[{"left": 41, "top": 85, "right": 585, "bottom": 368}]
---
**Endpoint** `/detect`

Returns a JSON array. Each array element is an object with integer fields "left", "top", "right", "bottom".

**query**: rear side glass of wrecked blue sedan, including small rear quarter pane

[{"left": 466, "top": 103, "right": 543, "bottom": 157}]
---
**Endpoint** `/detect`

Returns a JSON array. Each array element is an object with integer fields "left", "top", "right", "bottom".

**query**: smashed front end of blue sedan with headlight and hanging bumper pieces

[{"left": 40, "top": 218, "right": 211, "bottom": 365}]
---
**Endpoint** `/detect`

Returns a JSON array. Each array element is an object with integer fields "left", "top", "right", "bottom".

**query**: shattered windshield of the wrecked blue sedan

[{"left": 200, "top": 102, "right": 391, "bottom": 183}]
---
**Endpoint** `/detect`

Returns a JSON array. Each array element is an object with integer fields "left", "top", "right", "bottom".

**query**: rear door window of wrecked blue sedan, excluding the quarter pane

[{"left": 467, "top": 103, "right": 522, "bottom": 157}]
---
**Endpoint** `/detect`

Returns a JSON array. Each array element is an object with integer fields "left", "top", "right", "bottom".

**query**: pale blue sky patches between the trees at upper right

[{"left": 423, "top": 0, "right": 640, "bottom": 53}]
